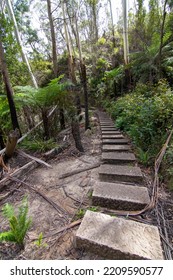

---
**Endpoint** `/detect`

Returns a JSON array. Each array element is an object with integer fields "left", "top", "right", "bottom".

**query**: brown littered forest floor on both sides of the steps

[{"left": 0, "top": 110, "right": 173, "bottom": 260}]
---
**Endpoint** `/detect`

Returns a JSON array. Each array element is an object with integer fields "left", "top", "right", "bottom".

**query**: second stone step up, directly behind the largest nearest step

[{"left": 92, "top": 182, "right": 150, "bottom": 211}]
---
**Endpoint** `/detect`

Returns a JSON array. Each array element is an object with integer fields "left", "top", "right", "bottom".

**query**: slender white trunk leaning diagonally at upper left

[{"left": 5, "top": 0, "right": 38, "bottom": 88}]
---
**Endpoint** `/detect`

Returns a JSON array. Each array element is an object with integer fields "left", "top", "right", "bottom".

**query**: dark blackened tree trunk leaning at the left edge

[{"left": 0, "top": 37, "right": 21, "bottom": 136}]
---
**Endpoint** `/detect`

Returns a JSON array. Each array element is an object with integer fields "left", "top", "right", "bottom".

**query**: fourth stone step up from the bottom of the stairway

[{"left": 102, "top": 152, "right": 136, "bottom": 164}]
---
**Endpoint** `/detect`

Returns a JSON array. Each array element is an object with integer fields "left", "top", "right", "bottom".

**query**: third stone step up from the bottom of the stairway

[{"left": 99, "top": 164, "right": 143, "bottom": 183}]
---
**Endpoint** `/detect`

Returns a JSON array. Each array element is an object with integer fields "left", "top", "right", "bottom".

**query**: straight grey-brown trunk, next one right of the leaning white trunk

[{"left": 47, "top": 0, "right": 58, "bottom": 78}]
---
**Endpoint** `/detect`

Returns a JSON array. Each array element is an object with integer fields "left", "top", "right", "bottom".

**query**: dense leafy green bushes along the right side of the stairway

[{"left": 103, "top": 80, "right": 173, "bottom": 189}]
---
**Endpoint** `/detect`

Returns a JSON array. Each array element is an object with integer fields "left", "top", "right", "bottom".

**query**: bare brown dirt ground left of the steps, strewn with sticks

[{"left": 0, "top": 114, "right": 104, "bottom": 260}]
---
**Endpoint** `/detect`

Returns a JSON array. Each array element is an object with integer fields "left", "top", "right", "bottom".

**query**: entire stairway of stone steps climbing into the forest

[{"left": 76, "top": 113, "right": 164, "bottom": 260}]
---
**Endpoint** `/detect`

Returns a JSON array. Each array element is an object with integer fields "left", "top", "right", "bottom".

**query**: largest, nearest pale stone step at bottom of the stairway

[{"left": 76, "top": 210, "right": 163, "bottom": 260}]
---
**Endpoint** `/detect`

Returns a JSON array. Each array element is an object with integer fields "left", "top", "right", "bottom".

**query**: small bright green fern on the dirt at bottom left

[{"left": 0, "top": 197, "right": 31, "bottom": 247}]
